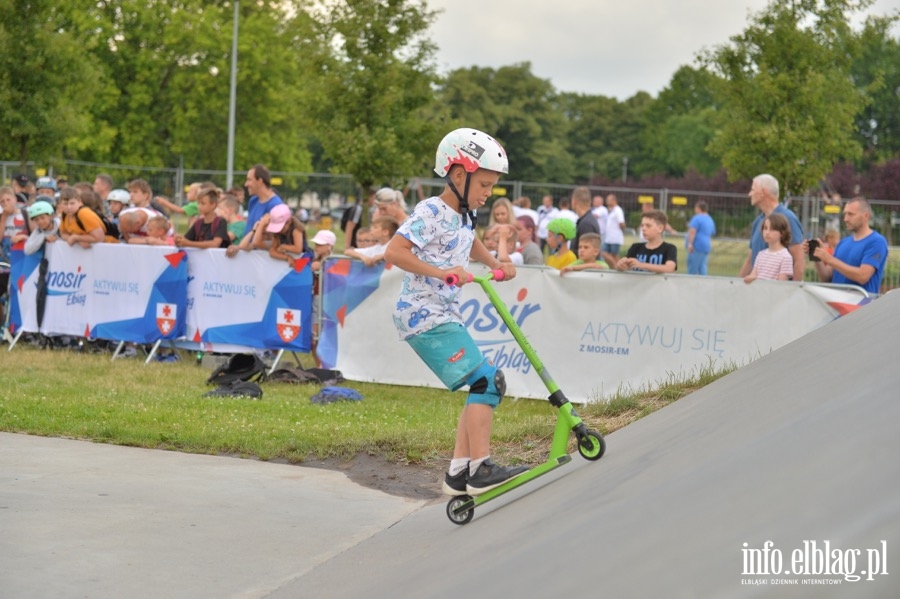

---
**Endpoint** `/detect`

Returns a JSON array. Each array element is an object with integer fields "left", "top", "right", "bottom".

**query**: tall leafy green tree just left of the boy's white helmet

[{"left": 307, "top": 0, "right": 440, "bottom": 187}]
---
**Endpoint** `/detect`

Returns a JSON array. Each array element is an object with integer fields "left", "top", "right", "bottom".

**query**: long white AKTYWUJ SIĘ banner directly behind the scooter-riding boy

[{"left": 319, "top": 259, "right": 868, "bottom": 402}]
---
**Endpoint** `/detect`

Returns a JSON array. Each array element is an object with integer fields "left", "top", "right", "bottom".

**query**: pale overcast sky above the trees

[{"left": 427, "top": 0, "right": 900, "bottom": 100}]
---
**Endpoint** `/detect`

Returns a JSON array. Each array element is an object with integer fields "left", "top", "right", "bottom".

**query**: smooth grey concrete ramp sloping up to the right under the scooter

[{"left": 286, "top": 292, "right": 900, "bottom": 598}]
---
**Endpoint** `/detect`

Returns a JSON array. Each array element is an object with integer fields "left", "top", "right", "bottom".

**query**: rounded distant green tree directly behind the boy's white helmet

[{"left": 438, "top": 63, "right": 572, "bottom": 181}]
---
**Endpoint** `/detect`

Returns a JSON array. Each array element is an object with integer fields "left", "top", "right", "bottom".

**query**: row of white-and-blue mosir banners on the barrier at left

[{"left": 10, "top": 243, "right": 312, "bottom": 353}]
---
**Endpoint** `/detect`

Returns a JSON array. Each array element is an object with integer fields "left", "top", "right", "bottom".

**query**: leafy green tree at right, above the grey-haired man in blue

[{"left": 702, "top": 0, "right": 871, "bottom": 193}]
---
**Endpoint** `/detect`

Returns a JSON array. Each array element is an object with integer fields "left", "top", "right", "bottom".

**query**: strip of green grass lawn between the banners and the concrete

[{"left": 0, "top": 343, "right": 723, "bottom": 474}]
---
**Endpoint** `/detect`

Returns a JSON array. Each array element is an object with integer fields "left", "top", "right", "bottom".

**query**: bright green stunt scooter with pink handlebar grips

[{"left": 445, "top": 270, "right": 606, "bottom": 525}]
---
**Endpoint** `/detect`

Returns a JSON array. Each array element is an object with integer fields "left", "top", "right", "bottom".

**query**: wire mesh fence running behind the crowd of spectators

[{"left": 0, "top": 161, "right": 900, "bottom": 291}]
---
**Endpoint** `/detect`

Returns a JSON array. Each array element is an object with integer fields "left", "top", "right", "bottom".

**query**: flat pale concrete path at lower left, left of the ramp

[{"left": 0, "top": 433, "right": 424, "bottom": 599}]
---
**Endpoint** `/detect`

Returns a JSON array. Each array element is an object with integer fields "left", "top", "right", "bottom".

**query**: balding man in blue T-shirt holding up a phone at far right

[{"left": 804, "top": 197, "right": 888, "bottom": 294}]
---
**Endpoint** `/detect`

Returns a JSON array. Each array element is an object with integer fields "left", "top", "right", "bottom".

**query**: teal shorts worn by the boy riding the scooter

[{"left": 406, "top": 322, "right": 484, "bottom": 391}]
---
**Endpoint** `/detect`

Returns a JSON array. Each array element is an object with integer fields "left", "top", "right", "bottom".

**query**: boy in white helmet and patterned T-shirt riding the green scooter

[{"left": 385, "top": 128, "right": 528, "bottom": 496}]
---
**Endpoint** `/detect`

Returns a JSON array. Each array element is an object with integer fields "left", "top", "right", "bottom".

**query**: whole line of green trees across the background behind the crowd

[{"left": 0, "top": 0, "right": 900, "bottom": 199}]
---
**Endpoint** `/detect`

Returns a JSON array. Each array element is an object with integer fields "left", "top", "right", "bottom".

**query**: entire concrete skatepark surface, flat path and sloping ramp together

[{"left": 0, "top": 292, "right": 900, "bottom": 599}]
